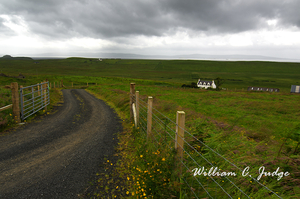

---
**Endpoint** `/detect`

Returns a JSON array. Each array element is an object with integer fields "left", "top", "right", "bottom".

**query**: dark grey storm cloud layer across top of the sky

[{"left": 0, "top": 0, "right": 300, "bottom": 39}]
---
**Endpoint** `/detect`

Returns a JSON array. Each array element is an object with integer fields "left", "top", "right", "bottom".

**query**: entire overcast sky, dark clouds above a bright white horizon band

[{"left": 0, "top": 0, "right": 300, "bottom": 59}]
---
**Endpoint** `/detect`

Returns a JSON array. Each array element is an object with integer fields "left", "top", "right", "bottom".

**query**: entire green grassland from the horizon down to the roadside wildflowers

[{"left": 0, "top": 58, "right": 300, "bottom": 198}]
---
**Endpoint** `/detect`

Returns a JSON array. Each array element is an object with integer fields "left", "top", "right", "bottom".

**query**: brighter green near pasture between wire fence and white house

[{"left": 88, "top": 79, "right": 300, "bottom": 198}]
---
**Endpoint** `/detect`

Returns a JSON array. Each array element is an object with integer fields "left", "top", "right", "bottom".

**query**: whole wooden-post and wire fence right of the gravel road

[{"left": 130, "top": 84, "right": 281, "bottom": 198}]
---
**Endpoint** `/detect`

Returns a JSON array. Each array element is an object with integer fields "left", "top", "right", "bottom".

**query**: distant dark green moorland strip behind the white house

[{"left": 0, "top": 58, "right": 300, "bottom": 92}]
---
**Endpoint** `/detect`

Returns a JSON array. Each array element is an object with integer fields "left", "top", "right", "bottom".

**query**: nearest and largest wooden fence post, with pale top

[{"left": 175, "top": 111, "right": 185, "bottom": 175}]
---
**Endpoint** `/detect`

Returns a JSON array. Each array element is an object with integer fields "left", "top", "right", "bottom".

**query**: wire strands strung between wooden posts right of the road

[{"left": 131, "top": 92, "right": 281, "bottom": 198}]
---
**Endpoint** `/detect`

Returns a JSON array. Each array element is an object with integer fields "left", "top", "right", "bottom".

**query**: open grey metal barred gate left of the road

[{"left": 20, "top": 82, "right": 50, "bottom": 121}]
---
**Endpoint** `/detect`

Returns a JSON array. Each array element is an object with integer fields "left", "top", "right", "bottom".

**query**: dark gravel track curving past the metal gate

[{"left": 0, "top": 89, "right": 122, "bottom": 199}]
